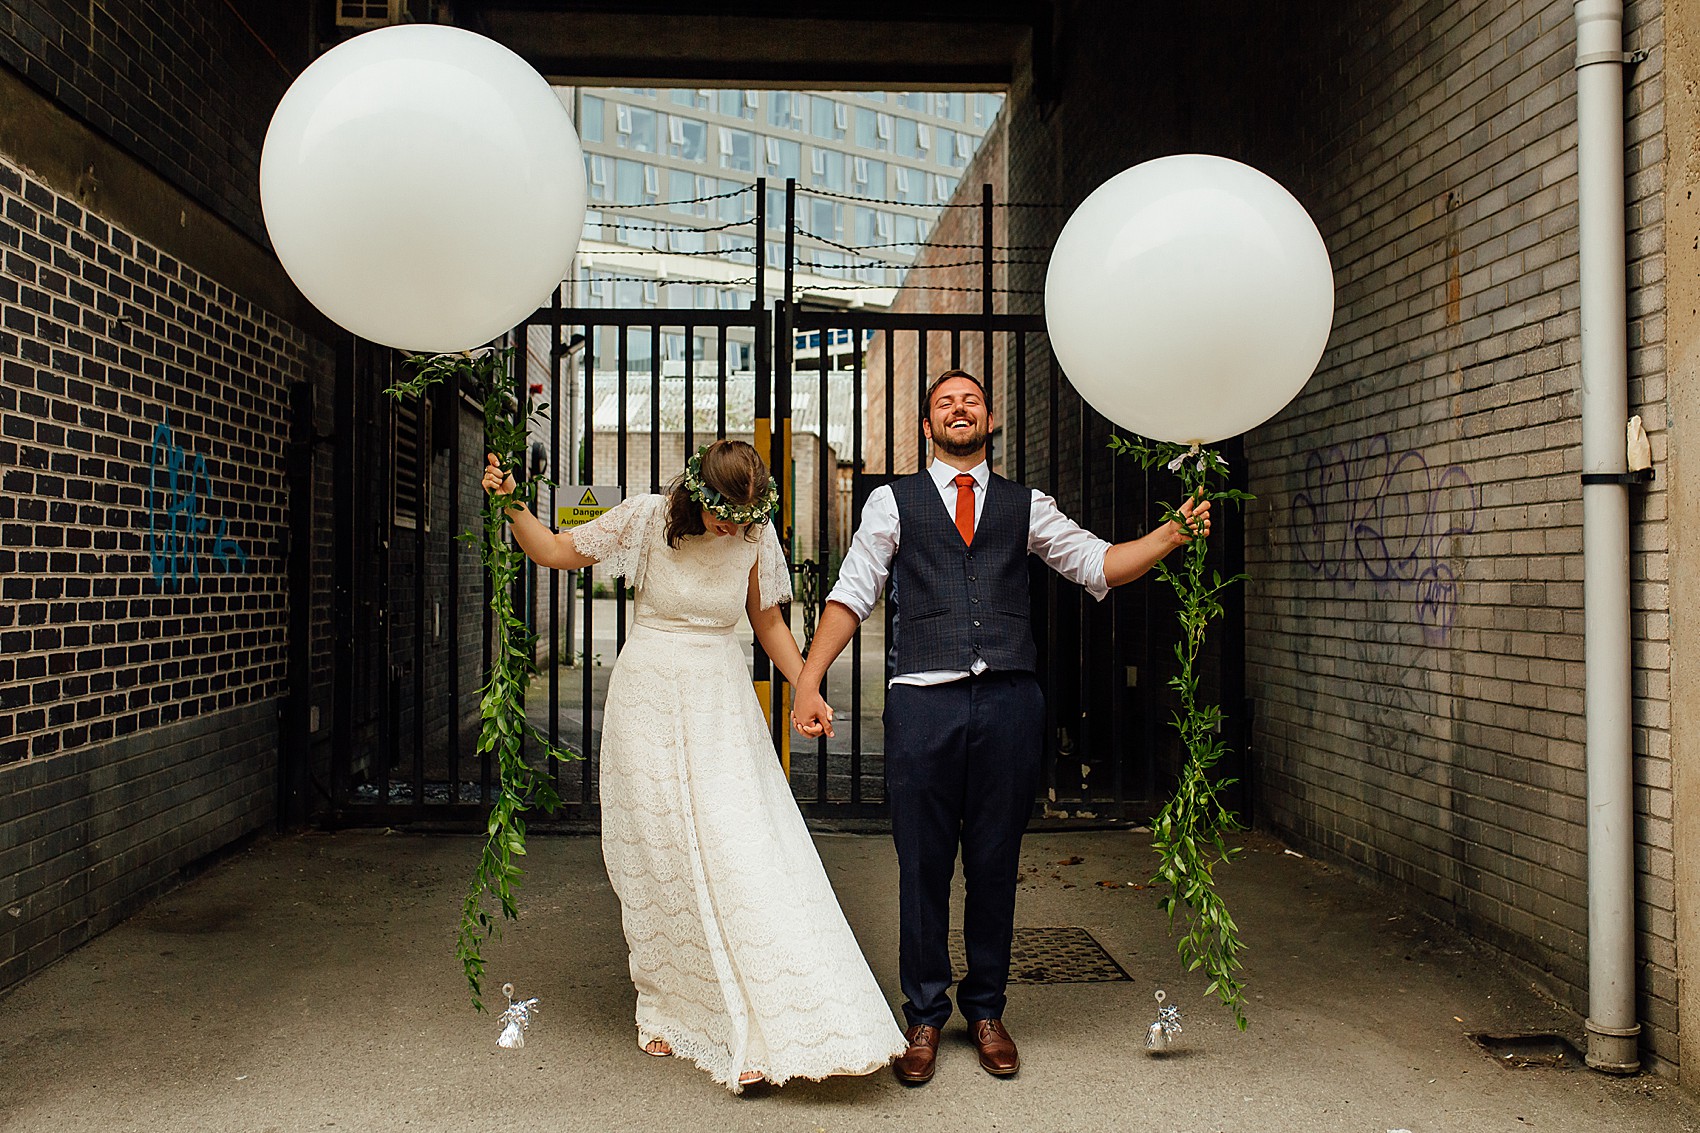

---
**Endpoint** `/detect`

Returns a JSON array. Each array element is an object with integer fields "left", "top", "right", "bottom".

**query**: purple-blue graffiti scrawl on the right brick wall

[{"left": 1292, "top": 434, "right": 1481, "bottom": 643}]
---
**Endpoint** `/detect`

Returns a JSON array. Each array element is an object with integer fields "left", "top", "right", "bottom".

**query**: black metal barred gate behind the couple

[{"left": 316, "top": 185, "right": 1243, "bottom": 825}]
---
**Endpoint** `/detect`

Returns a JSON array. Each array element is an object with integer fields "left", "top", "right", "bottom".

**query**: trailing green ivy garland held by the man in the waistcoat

[{"left": 1110, "top": 436, "right": 1255, "bottom": 1031}]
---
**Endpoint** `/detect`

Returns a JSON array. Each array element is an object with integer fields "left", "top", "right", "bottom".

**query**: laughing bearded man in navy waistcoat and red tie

[{"left": 792, "top": 369, "right": 1210, "bottom": 1085}]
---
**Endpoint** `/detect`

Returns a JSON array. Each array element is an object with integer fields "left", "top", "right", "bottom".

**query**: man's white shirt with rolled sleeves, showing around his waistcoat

[{"left": 826, "top": 461, "right": 1110, "bottom": 684}]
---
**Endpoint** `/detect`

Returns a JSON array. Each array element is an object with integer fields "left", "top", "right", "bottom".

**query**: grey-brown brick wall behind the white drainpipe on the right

[{"left": 1006, "top": 0, "right": 1678, "bottom": 1063}]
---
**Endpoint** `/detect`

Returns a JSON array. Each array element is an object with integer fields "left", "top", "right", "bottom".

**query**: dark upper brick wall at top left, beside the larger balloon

[{"left": 0, "top": 0, "right": 299, "bottom": 245}]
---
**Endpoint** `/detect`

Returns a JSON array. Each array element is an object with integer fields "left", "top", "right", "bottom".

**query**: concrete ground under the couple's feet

[{"left": 0, "top": 819, "right": 1700, "bottom": 1133}]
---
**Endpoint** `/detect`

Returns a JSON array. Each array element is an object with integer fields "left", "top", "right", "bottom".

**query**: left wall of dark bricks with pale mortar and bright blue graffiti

[{"left": 0, "top": 148, "right": 328, "bottom": 976}]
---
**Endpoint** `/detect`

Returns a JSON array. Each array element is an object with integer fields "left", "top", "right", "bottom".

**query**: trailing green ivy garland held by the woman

[{"left": 386, "top": 349, "right": 580, "bottom": 1011}]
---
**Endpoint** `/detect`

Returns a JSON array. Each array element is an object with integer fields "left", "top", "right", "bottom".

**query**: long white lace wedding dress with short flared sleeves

[{"left": 573, "top": 495, "right": 904, "bottom": 1092}]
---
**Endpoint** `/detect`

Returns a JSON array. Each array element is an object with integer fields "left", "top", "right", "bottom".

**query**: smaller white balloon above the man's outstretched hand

[{"left": 1046, "top": 153, "right": 1335, "bottom": 444}]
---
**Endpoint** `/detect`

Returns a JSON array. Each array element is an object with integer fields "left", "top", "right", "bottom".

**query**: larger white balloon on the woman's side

[{"left": 260, "top": 24, "right": 585, "bottom": 352}]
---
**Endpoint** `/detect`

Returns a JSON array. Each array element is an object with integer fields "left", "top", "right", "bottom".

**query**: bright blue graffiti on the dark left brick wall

[{"left": 148, "top": 415, "right": 248, "bottom": 589}]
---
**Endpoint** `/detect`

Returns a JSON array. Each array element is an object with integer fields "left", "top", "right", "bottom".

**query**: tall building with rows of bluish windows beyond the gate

[{"left": 563, "top": 87, "right": 1003, "bottom": 373}]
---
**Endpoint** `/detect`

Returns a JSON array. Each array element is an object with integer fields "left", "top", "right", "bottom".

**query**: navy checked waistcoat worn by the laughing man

[{"left": 891, "top": 471, "right": 1039, "bottom": 674}]
